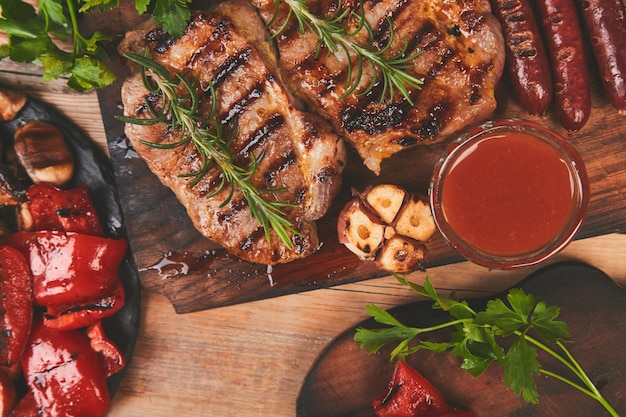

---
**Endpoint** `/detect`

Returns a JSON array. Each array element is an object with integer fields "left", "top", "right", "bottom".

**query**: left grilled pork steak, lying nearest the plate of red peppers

[{"left": 119, "top": 2, "right": 345, "bottom": 265}]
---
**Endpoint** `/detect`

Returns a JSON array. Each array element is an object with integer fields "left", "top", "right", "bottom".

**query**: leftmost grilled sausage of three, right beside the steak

[{"left": 491, "top": 0, "right": 553, "bottom": 114}]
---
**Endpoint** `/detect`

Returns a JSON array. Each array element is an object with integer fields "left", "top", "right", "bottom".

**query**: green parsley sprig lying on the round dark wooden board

[{"left": 354, "top": 276, "right": 619, "bottom": 417}]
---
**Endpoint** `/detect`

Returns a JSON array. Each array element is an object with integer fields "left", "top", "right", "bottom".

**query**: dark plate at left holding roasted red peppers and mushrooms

[{"left": 0, "top": 99, "right": 139, "bottom": 395}]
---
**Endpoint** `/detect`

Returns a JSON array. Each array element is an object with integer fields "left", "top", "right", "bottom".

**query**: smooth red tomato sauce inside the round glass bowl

[{"left": 441, "top": 132, "right": 575, "bottom": 256}]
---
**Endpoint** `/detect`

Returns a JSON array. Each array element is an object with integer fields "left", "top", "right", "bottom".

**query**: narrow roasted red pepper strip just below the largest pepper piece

[{"left": 43, "top": 281, "right": 124, "bottom": 330}]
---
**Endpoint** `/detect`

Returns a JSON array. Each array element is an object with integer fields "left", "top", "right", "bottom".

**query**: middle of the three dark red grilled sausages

[{"left": 537, "top": 0, "right": 591, "bottom": 131}]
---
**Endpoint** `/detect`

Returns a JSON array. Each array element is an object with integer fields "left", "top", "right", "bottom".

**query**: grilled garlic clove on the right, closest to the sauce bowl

[{"left": 394, "top": 194, "right": 436, "bottom": 242}]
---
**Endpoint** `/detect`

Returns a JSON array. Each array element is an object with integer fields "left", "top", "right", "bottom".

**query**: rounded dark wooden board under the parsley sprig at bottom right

[{"left": 297, "top": 262, "right": 626, "bottom": 417}]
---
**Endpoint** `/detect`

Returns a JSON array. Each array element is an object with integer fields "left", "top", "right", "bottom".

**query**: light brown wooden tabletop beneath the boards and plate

[{"left": 0, "top": 62, "right": 626, "bottom": 417}]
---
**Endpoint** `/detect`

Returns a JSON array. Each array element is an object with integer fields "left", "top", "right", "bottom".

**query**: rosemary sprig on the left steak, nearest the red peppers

[{"left": 117, "top": 54, "right": 299, "bottom": 249}]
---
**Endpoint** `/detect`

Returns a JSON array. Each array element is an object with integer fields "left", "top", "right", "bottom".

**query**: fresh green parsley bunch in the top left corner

[{"left": 0, "top": 0, "right": 191, "bottom": 91}]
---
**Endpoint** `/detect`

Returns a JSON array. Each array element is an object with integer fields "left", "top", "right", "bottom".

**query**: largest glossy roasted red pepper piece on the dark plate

[{"left": 6, "top": 231, "right": 128, "bottom": 306}]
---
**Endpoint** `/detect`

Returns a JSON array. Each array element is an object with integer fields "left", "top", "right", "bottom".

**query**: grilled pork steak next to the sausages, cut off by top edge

[{"left": 252, "top": 0, "right": 504, "bottom": 174}]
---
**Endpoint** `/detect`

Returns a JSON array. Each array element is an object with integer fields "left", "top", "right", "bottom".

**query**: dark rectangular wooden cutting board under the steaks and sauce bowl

[{"left": 90, "top": 7, "right": 626, "bottom": 313}]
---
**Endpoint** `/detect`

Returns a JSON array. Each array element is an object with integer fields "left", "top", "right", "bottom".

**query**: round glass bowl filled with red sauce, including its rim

[{"left": 430, "top": 120, "right": 589, "bottom": 269}]
